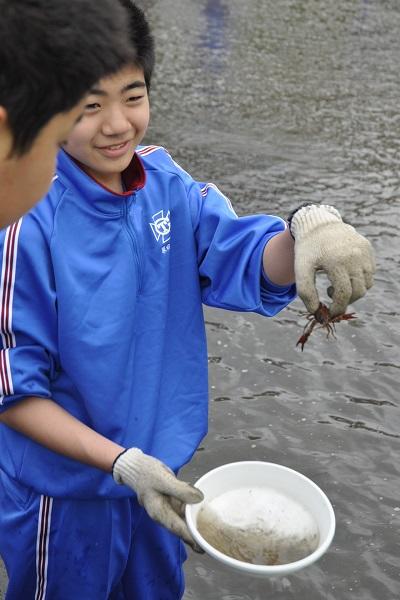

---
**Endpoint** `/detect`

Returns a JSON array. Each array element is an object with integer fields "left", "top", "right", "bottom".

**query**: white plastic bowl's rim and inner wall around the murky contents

[{"left": 186, "top": 461, "right": 335, "bottom": 577}]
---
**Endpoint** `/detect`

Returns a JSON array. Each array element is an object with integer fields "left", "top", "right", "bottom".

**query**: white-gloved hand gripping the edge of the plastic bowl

[{"left": 112, "top": 448, "right": 203, "bottom": 553}]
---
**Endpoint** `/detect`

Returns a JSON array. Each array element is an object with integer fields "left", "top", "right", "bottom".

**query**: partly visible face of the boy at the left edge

[{"left": 0, "top": 101, "right": 84, "bottom": 228}]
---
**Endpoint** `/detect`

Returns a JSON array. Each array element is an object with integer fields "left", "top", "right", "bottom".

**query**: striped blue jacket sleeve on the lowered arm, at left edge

[{"left": 0, "top": 202, "right": 57, "bottom": 411}]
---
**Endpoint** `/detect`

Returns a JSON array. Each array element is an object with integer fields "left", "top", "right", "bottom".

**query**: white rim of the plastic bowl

[{"left": 185, "top": 460, "right": 336, "bottom": 576}]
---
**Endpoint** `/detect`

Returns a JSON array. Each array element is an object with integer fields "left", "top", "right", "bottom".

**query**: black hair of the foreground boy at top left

[{"left": 0, "top": 0, "right": 135, "bottom": 155}]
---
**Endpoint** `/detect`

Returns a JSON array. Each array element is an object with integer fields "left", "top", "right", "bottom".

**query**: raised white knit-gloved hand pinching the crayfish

[{"left": 289, "top": 204, "right": 375, "bottom": 317}]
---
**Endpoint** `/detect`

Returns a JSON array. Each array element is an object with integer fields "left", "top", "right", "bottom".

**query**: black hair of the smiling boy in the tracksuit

[{"left": 119, "top": 0, "right": 155, "bottom": 91}]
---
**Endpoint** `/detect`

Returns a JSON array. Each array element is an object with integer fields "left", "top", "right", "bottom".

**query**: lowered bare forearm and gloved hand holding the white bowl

[{"left": 0, "top": 397, "right": 203, "bottom": 552}]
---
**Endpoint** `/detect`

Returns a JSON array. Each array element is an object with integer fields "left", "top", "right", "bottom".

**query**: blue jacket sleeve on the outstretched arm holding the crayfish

[{"left": 189, "top": 183, "right": 296, "bottom": 316}]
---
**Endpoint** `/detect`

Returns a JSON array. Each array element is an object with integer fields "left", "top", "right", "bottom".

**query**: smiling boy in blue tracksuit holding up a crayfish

[{"left": 0, "top": 2, "right": 373, "bottom": 600}]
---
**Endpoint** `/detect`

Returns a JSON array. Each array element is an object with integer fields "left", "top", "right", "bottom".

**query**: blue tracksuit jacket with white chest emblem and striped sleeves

[{"left": 0, "top": 146, "right": 295, "bottom": 498}]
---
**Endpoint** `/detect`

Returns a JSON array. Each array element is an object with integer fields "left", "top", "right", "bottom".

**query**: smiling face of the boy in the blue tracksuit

[{"left": 64, "top": 66, "right": 150, "bottom": 192}]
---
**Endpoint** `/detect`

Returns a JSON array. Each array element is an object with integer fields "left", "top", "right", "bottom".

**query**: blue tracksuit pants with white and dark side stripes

[{"left": 0, "top": 471, "right": 186, "bottom": 600}]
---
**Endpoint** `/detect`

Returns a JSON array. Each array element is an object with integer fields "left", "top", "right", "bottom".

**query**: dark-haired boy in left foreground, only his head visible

[{"left": 0, "top": 0, "right": 136, "bottom": 227}]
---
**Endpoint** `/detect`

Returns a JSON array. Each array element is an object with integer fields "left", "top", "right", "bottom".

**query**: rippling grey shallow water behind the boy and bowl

[{"left": 1, "top": 0, "right": 400, "bottom": 600}]
